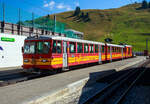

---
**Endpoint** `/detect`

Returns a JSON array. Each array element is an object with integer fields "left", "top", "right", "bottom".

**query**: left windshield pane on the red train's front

[{"left": 24, "top": 42, "right": 35, "bottom": 54}]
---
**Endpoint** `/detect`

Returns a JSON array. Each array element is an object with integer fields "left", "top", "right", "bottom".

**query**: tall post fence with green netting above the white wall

[{"left": 0, "top": 3, "right": 80, "bottom": 38}]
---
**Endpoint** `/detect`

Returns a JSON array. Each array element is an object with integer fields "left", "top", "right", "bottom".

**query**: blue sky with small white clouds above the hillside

[{"left": 0, "top": 0, "right": 146, "bottom": 22}]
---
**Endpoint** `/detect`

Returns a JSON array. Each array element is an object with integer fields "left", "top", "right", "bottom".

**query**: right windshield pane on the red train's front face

[{"left": 36, "top": 42, "right": 50, "bottom": 54}]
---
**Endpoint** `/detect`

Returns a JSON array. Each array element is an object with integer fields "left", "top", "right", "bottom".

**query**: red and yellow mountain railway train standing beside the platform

[{"left": 22, "top": 36, "right": 132, "bottom": 71}]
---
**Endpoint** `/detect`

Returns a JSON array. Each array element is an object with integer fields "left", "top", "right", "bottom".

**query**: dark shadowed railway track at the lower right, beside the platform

[{"left": 83, "top": 60, "right": 150, "bottom": 104}]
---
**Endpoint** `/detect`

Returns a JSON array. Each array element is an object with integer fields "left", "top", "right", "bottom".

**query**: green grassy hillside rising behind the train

[{"left": 47, "top": 4, "right": 150, "bottom": 51}]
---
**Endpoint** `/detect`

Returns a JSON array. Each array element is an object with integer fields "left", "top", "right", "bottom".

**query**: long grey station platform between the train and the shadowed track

[{"left": 0, "top": 56, "right": 146, "bottom": 104}]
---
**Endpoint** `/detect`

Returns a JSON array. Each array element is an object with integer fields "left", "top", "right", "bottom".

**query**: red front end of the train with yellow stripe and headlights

[{"left": 22, "top": 39, "right": 51, "bottom": 71}]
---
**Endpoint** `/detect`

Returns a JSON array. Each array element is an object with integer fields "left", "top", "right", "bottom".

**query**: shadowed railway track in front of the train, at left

[{"left": 0, "top": 69, "right": 64, "bottom": 87}]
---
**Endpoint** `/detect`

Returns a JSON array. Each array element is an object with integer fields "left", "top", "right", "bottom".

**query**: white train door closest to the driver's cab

[{"left": 63, "top": 41, "right": 68, "bottom": 69}]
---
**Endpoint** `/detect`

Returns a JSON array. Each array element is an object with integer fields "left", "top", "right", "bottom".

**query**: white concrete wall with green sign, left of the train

[{"left": 0, "top": 33, "right": 26, "bottom": 68}]
